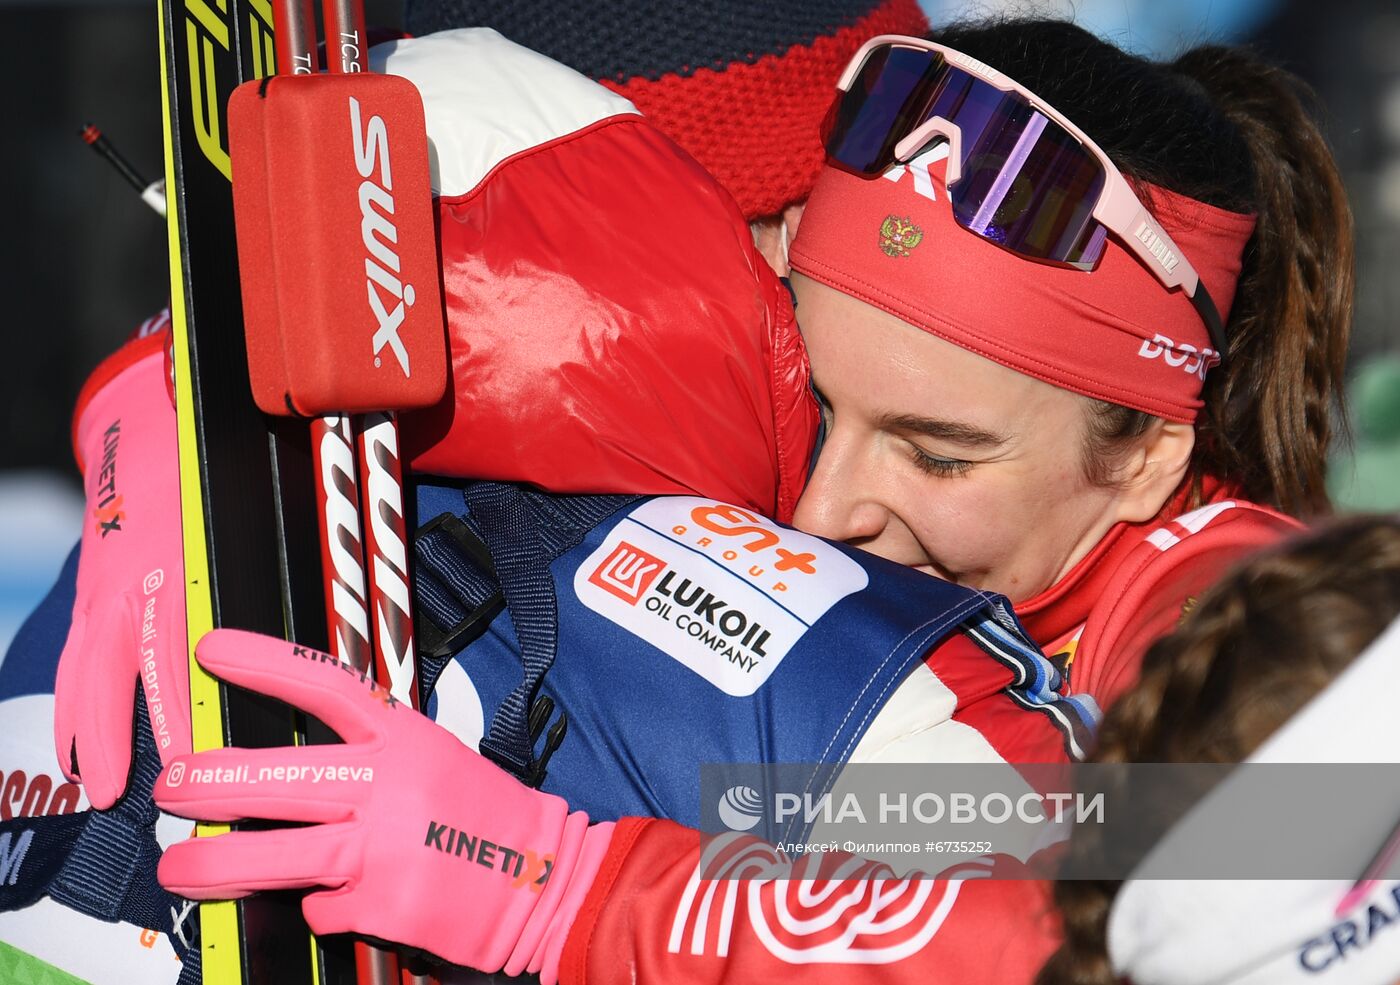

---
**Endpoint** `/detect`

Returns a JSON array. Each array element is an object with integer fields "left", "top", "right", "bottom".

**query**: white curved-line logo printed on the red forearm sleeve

[{"left": 666, "top": 834, "right": 987, "bottom": 965}]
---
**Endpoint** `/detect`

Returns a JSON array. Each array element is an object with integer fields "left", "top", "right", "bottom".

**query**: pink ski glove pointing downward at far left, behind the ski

[{"left": 53, "top": 339, "right": 190, "bottom": 809}]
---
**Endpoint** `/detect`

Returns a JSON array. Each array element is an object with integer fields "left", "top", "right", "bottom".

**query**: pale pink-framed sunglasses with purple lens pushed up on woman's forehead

[{"left": 822, "top": 35, "right": 1225, "bottom": 355}]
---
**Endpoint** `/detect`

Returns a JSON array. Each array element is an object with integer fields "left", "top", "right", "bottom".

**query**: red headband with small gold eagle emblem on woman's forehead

[{"left": 791, "top": 154, "right": 1254, "bottom": 423}]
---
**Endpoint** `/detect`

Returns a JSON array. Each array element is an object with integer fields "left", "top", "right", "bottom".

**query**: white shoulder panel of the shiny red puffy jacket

[{"left": 370, "top": 28, "right": 637, "bottom": 197}]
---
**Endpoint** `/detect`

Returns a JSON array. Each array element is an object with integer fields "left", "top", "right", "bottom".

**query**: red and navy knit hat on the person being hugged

[{"left": 406, "top": 0, "right": 928, "bottom": 218}]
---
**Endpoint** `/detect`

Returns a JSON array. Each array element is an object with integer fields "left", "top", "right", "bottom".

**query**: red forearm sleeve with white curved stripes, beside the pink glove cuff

[{"left": 560, "top": 819, "right": 1057, "bottom": 985}]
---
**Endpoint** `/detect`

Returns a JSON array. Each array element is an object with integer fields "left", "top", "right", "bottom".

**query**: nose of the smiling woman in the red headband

[{"left": 792, "top": 428, "right": 889, "bottom": 544}]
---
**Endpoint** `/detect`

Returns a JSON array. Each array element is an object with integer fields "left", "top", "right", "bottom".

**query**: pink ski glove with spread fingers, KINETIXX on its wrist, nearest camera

[{"left": 155, "top": 630, "right": 613, "bottom": 985}]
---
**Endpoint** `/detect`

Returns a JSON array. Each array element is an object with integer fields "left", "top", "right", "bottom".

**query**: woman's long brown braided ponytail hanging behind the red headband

[{"left": 1170, "top": 46, "right": 1354, "bottom": 515}]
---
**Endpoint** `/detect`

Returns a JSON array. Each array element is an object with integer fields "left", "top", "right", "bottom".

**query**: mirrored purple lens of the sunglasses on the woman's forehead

[{"left": 826, "top": 46, "right": 1106, "bottom": 270}]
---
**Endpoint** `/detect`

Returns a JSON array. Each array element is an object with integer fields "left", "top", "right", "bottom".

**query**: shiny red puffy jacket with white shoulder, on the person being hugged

[{"left": 374, "top": 29, "right": 818, "bottom": 519}]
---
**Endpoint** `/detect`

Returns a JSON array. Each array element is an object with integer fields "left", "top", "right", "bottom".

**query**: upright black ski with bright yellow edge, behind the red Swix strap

[{"left": 160, "top": 0, "right": 354, "bottom": 985}]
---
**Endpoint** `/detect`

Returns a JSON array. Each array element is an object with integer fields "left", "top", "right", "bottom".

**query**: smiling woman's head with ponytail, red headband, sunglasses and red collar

[{"left": 791, "top": 22, "right": 1352, "bottom": 707}]
